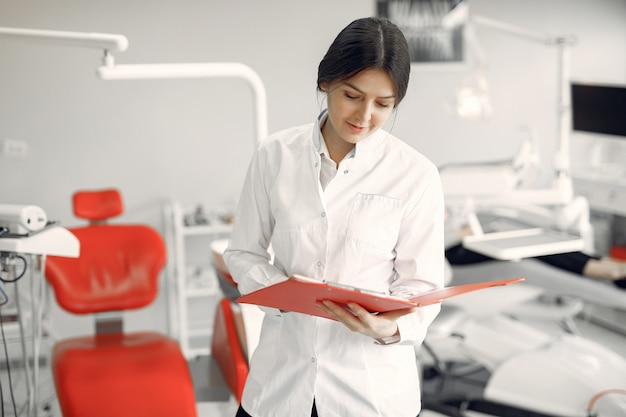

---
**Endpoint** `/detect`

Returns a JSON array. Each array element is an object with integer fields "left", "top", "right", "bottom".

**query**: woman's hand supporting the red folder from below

[{"left": 316, "top": 300, "right": 415, "bottom": 339}]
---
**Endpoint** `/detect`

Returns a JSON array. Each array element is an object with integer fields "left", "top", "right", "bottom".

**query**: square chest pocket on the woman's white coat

[{"left": 347, "top": 193, "right": 402, "bottom": 251}]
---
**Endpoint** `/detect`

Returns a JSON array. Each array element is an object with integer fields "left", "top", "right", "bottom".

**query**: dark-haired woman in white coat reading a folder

[{"left": 224, "top": 18, "right": 444, "bottom": 417}]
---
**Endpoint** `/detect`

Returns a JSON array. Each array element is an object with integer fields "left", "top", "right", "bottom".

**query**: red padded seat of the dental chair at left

[{"left": 52, "top": 332, "right": 197, "bottom": 417}]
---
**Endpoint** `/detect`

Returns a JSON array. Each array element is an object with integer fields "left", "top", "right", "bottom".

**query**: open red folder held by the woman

[{"left": 235, "top": 275, "right": 524, "bottom": 319}]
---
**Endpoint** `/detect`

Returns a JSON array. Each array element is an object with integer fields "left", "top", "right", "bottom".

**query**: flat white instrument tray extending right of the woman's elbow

[{"left": 463, "top": 228, "right": 584, "bottom": 261}]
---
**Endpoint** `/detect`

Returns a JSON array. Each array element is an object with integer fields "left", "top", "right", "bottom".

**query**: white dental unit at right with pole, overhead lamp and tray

[{"left": 441, "top": 7, "right": 593, "bottom": 259}]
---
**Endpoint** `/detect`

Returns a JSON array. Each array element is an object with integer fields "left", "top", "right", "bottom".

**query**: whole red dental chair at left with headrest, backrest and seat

[{"left": 45, "top": 189, "right": 197, "bottom": 417}]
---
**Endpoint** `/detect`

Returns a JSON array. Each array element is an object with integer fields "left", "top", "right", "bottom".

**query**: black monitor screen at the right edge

[{"left": 571, "top": 83, "right": 626, "bottom": 137}]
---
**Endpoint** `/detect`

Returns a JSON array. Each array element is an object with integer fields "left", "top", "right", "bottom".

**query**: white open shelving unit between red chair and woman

[{"left": 164, "top": 201, "right": 231, "bottom": 359}]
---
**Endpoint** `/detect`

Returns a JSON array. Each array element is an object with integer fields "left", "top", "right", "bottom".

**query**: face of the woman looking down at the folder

[{"left": 321, "top": 69, "right": 396, "bottom": 145}]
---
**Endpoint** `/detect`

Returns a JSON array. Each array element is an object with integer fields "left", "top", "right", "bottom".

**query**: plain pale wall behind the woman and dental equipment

[{"left": 0, "top": 0, "right": 626, "bottom": 334}]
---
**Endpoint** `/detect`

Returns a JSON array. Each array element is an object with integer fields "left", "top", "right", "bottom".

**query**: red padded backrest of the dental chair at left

[{"left": 45, "top": 225, "right": 166, "bottom": 314}]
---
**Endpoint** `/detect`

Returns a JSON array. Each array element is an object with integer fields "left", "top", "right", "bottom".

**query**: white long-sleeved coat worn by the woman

[{"left": 224, "top": 113, "right": 444, "bottom": 417}]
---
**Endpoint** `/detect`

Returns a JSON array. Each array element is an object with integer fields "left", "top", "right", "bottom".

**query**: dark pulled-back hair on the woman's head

[{"left": 317, "top": 17, "right": 411, "bottom": 105}]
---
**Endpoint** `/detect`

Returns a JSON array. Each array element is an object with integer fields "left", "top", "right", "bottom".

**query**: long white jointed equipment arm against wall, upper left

[{"left": 0, "top": 27, "right": 268, "bottom": 142}]
